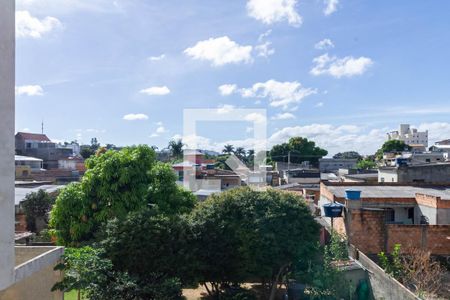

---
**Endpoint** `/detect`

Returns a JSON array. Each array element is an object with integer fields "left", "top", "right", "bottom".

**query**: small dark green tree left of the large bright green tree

[{"left": 21, "top": 190, "right": 55, "bottom": 232}]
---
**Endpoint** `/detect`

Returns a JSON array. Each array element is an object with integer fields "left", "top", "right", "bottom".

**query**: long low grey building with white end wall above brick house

[{"left": 378, "top": 163, "right": 450, "bottom": 184}]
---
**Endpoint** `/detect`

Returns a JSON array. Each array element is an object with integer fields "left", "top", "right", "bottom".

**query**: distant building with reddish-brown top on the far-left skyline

[{"left": 15, "top": 132, "right": 73, "bottom": 169}]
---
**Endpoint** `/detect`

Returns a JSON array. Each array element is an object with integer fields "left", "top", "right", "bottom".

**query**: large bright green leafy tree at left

[{"left": 50, "top": 146, "right": 195, "bottom": 245}]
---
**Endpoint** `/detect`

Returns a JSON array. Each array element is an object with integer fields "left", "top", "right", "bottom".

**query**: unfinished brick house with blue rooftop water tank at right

[{"left": 319, "top": 182, "right": 450, "bottom": 255}]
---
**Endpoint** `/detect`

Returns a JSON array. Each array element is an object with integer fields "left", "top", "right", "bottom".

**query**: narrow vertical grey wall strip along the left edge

[{"left": 0, "top": 0, "right": 15, "bottom": 290}]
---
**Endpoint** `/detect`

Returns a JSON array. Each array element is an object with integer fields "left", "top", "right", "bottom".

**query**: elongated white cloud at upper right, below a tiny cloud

[{"left": 310, "top": 53, "right": 373, "bottom": 78}]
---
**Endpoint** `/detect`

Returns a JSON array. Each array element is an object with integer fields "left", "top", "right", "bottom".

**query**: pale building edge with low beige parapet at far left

[{"left": 0, "top": 4, "right": 63, "bottom": 300}]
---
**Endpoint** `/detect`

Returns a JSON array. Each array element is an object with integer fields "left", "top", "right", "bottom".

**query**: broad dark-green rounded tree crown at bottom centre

[{"left": 191, "top": 188, "right": 318, "bottom": 296}]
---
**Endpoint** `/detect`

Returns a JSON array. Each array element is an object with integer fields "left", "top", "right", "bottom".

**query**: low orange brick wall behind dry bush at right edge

[{"left": 386, "top": 224, "right": 450, "bottom": 255}]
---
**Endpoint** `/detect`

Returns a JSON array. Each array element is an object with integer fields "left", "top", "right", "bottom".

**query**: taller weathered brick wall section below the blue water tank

[{"left": 347, "top": 209, "right": 385, "bottom": 254}]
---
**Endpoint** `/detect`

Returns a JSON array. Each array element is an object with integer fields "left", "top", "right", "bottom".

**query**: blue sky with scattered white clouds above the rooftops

[{"left": 16, "top": 0, "right": 450, "bottom": 155}]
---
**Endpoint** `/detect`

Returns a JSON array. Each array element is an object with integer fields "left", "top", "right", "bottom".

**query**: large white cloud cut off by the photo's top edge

[{"left": 247, "top": 0, "right": 302, "bottom": 26}]
